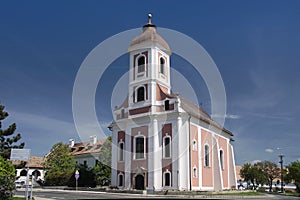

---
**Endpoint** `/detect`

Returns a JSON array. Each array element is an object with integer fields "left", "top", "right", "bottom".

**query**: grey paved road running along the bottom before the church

[{"left": 16, "top": 189, "right": 300, "bottom": 200}]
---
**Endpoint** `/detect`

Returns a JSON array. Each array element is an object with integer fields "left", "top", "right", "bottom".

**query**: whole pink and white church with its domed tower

[{"left": 109, "top": 15, "right": 236, "bottom": 191}]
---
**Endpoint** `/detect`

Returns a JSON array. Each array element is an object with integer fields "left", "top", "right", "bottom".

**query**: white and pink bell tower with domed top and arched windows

[{"left": 128, "top": 14, "right": 171, "bottom": 108}]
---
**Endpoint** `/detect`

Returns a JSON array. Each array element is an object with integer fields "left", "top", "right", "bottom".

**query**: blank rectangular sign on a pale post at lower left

[{"left": 10, "top": 149, "right": 32, "bottom": 200}]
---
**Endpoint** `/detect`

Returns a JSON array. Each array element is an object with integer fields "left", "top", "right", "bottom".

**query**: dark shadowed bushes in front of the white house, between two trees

[{"left": 68, "top": 164, "right": 96, "bottom": 187}]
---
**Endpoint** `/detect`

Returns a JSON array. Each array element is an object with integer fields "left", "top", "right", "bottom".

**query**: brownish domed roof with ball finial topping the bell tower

[{"left": 130, "top": 15, "right": 171, "bottom": 54}]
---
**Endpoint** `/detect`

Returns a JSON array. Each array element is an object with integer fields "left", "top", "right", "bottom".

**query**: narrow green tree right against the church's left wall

[{"left": 93, "top": 137, "right": 112, "bottom": 185}]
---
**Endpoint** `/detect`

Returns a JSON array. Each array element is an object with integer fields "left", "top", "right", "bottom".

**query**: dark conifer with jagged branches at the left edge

[{"left": 0, "top": 104, "right": 25, "bottom": 160}]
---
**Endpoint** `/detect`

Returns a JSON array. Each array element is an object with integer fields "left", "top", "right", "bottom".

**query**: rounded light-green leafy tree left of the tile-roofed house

[{"left": 44, "top": 142, "right": 76, "bottom": 186}]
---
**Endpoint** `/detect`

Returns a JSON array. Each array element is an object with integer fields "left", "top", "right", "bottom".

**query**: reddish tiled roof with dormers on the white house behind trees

[{"left": 71, "top": 140, "right": 105, "bottom": 155}]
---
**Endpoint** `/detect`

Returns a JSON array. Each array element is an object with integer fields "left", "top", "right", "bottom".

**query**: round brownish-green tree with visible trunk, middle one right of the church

[{"left": 255, "top": 161, "right": 280, "bottom": 192}]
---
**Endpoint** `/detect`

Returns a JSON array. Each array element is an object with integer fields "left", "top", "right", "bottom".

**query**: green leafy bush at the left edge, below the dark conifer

[{"left": 0, "top": 156, "right": 16, "bottom": 200}]
